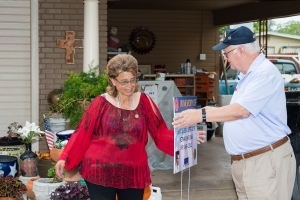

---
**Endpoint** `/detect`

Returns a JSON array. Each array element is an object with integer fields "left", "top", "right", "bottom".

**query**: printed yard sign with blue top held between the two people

[{"left": 173, "top": 96, "right": 197, "bottom": 174}]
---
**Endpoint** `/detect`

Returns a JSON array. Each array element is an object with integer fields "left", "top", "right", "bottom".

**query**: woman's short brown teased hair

[{"left": 106, "top": 54, "right": 139, "bottom": 97}]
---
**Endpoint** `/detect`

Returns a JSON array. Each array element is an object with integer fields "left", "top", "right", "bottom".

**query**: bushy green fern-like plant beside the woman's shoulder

[{"left": 57, "top": 66, "right": 108, "bottom": 128}]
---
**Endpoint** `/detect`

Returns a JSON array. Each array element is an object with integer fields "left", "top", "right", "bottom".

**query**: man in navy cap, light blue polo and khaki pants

[{"left": 173, "top": 26, "right": 296, "bottom": 200}]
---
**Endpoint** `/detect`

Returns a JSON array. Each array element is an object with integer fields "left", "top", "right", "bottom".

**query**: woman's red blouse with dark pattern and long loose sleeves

[{"left": 60, "top": 93, "right": 174, "bottom": 189}]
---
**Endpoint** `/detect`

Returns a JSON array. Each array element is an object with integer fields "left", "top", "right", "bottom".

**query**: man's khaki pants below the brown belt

[{"left": 231, "top": 140, "right": 296, "bottom": 200}]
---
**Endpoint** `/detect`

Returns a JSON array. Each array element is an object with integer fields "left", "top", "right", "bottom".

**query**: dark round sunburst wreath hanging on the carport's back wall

[{"left": 129, "top": 27, "right": 156, "bottom": 54}]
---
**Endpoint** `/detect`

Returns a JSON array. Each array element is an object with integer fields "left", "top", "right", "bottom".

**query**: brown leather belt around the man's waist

[{"left": 231, "top": 136, "right": 289, "bottom": 161}]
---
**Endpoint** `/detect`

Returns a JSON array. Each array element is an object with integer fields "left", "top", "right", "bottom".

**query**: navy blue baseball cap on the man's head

[{"left": 213, "top": 26, "right": 256, "bottom": 51}]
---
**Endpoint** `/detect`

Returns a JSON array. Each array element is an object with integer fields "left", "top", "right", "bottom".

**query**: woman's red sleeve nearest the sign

[{"left": 145, "top": 94, "right": 174, "bottom": 156}]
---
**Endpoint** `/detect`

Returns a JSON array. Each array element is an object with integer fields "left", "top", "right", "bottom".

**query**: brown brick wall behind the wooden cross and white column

[{"left": 39, "top": 0, "right": 107, "bottom": 151}]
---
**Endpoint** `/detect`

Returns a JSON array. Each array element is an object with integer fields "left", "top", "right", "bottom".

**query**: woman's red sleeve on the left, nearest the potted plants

[{"left": 59, "top": 97, "right": 104, "bottom": 170}]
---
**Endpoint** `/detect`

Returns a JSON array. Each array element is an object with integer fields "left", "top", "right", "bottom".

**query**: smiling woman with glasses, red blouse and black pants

[{"left": 55, "top": 54, "right": 204, "bottom": 200}]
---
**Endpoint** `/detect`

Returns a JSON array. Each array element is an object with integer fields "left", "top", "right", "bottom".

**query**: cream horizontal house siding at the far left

[{"left": 0, "top": 0, "right": 32, "bottom": 137}]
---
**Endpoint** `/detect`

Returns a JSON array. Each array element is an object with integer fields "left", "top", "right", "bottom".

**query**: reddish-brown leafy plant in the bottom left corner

[{"left": 0, "top": 176, "right": 27, "bottom": 199}]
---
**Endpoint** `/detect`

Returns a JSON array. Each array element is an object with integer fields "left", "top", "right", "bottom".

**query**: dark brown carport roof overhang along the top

[{"left": 108, "top": 0, "right": 300, "bottom": 26}]
